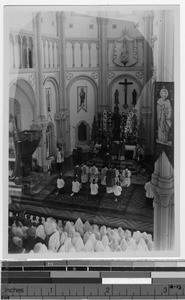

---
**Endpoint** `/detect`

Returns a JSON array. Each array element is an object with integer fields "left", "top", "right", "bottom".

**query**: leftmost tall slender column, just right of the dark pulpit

[{"left": 33, "top": 13, "right": 47, "bottom": 172}]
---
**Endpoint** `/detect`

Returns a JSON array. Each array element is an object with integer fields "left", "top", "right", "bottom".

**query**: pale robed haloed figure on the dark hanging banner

[{"left": 157, "top": 88, "right": 172, "bottom": 146}]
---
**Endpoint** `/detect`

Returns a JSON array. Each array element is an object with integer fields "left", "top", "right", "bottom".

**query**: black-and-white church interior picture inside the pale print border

[{"left": 6, "top": 5, "right": 178, "bottom": 257}]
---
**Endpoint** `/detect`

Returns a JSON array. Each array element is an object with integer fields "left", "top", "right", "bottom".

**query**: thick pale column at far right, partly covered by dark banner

[{"left": 152, "top": 11, "right": 175, "bottom": 250}]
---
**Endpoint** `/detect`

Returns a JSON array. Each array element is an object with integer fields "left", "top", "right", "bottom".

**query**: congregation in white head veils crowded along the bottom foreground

[{"left": 9, "top": 212, "right": 154, "bottom": 254}]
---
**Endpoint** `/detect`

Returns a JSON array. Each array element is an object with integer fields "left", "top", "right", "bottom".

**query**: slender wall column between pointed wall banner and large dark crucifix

[{"left": 97, "top": 18, "right": 108, "bottom": 111}]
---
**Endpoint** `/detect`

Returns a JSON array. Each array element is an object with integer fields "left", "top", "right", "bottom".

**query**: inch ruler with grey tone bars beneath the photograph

[{"left": 1, "top": 261, "right": 185, "bottom": 300}]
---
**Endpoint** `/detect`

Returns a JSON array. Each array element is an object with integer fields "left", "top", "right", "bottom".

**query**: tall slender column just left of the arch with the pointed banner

[{"left": 57, "top": 12, "right": 70, "bottom": 156}]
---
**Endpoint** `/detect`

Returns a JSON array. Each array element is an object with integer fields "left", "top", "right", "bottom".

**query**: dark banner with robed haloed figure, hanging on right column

[{"left": 154, "top": 82, "right": 174, "bottom": 165}]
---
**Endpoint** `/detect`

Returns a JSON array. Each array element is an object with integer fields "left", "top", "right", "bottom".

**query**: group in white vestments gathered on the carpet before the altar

[{"left": 57, "top": 164, "right": 132, "bottom": 201}]
